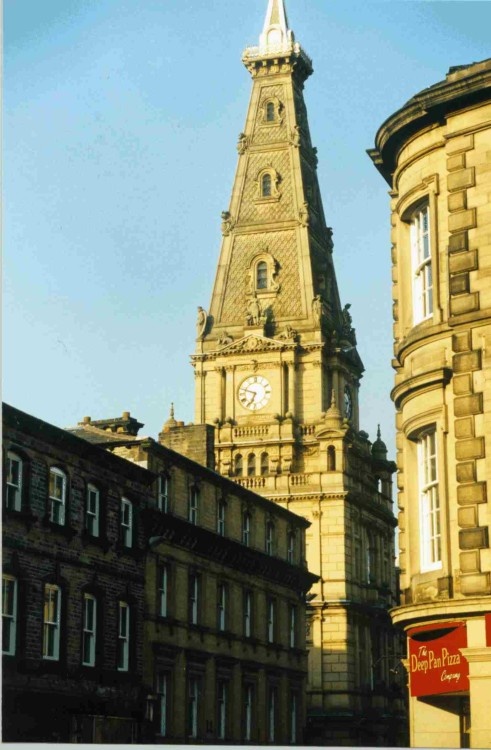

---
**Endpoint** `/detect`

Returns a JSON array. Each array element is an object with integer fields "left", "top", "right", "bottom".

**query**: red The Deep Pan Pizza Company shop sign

[{"left": 408, "top": 622, "right": 469, "bottom": 697}]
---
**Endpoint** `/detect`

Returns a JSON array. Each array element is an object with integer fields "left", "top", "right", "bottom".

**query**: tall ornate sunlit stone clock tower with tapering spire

[{"left": 192, "top": 0, "right": 400, "bottom": 745}]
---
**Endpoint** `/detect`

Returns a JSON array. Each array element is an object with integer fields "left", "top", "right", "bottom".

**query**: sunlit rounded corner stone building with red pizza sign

[{"left": 369, "top": 60, "right": 491, "bottom": 747}]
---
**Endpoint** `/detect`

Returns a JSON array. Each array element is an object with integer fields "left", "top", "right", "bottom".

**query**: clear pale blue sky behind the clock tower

[{"left": 3, "top": 0, "right": 491, "bottom": 455}]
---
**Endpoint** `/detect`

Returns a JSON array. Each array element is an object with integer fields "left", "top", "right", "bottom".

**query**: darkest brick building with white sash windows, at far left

[{"left": 2, "top": 404, "right": 150, "bottom": 743}]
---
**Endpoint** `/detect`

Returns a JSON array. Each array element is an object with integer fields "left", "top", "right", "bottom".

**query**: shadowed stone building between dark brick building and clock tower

[{"left": 115, "top": 440, "right": 316, "bottom": 745}]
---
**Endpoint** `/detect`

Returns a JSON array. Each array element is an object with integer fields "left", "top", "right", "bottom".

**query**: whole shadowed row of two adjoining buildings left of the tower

[{"left": 2, "top": 405, "right": 316, "bottom": 744}]
